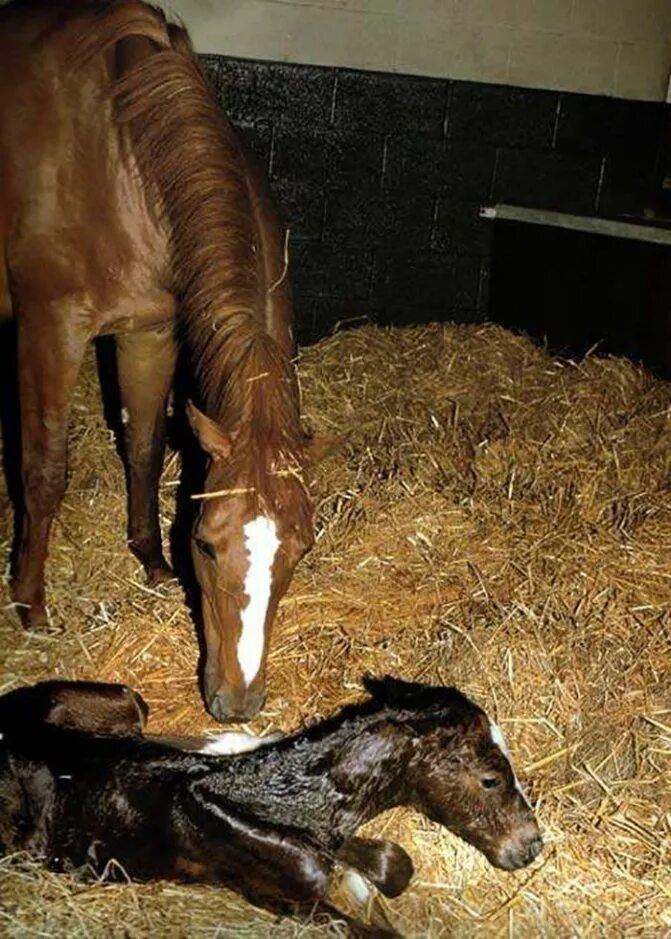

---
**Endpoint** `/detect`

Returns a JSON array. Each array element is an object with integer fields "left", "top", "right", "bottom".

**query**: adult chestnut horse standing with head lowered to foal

[{"left": 0, "top": 0, "right": 322, "bottom": 719}]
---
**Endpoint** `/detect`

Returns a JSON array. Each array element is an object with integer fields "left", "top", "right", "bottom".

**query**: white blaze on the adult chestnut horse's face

[{"left": 238, "top": 515, "right": 280, "bottom": 685}]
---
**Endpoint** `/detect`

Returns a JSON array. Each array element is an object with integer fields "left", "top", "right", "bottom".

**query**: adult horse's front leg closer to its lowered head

[{"left": 117, "top": 326, "right": 176, "bottom": 584}]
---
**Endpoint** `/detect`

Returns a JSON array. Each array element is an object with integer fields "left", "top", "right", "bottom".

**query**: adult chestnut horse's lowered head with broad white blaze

[{"left": 189, "top": 405, "right": 314, "bottom": 721}]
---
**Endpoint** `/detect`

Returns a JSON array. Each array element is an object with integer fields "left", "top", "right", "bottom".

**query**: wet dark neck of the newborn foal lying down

[{"left": 197, "top": 716, "right": 409, "bottom": 846}]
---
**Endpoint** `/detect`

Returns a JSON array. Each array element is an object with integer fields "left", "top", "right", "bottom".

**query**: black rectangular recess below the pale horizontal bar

[{"left": 488, "top": 221, "right": 671, "bottom": 378}]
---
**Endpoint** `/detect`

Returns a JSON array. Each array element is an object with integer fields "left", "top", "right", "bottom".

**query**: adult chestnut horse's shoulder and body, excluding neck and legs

[{"left": 0, "top": 0, "right": 173, "bottom": 334}]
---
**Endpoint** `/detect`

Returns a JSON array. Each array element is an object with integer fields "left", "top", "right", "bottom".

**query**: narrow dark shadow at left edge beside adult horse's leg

[{"left": 0, "top": 320, "right": 24, "bottom": 569}]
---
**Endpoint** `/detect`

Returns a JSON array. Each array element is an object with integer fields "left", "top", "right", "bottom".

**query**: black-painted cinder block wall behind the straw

[{"left": 202, "top": 55, "right": 668, "bottom": 343}]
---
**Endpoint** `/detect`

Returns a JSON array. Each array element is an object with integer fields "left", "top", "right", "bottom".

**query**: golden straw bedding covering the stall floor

[{"left": 0, "top": 325, "right": 671, "bottom": 937}]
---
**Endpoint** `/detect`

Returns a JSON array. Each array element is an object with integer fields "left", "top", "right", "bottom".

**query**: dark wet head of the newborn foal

[{"left": 366, "top": 678, "right": 543, "bottom": 870}]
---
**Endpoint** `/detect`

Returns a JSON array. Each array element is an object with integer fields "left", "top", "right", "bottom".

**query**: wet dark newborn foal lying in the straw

[{"left": 0, "top": 678, "right": 542, "bottom": 926}]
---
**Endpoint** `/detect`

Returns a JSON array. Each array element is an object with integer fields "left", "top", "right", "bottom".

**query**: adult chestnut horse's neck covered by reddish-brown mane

[{"left": 67, "top": 0, "right": 299, "bottom": 435}]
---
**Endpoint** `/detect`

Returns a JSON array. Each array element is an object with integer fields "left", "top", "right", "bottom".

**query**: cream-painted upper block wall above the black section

[{"left": 163, "top": 0, "right": 671, "bottom": 101}]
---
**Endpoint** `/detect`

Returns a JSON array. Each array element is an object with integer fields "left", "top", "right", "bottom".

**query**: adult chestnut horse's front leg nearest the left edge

[{"left": 11, "top": 306, "right": 88, "bottom": 628}]
